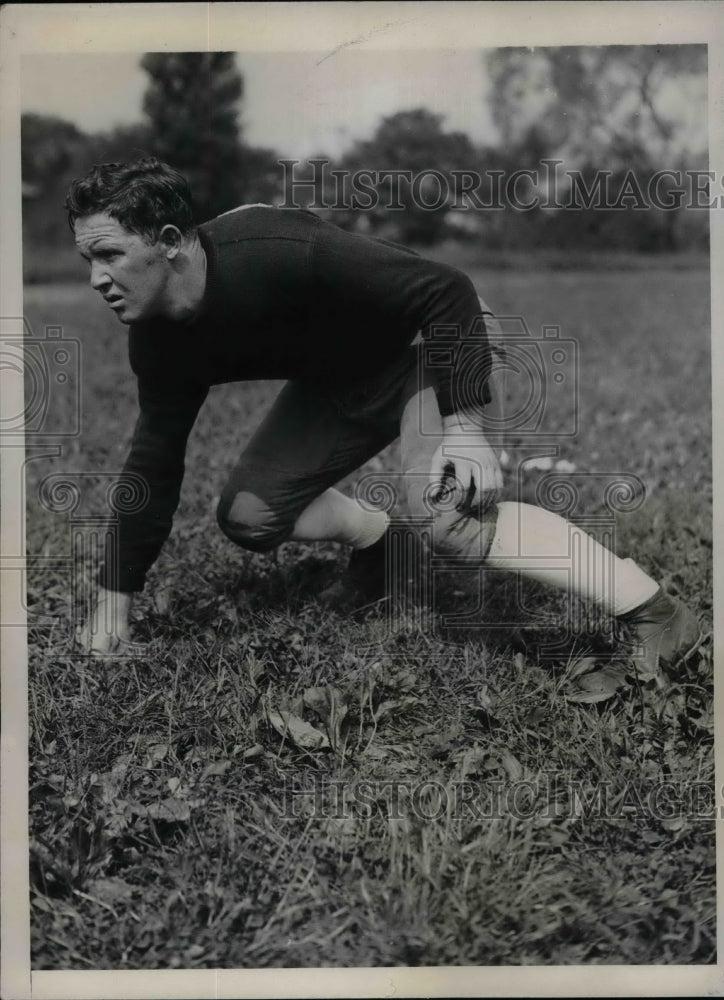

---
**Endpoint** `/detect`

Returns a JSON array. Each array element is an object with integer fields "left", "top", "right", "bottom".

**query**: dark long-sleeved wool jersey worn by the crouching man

[{"left": 99, "top": 206, "right": 490, "bottom": 591}]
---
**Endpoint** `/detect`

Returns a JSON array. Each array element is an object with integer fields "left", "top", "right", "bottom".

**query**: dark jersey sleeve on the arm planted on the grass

[{"left": 98, "top": 383, "right": 207, "bottom": 592}]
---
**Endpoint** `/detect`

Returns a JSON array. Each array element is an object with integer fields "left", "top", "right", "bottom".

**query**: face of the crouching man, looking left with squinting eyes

[{"left": 75, "top": 212, "right": 170, "bottom": 324}]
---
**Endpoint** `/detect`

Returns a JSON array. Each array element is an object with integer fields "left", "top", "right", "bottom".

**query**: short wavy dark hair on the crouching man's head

[{"left": 65, "top": 156, "right": 194, "bottom": 243}]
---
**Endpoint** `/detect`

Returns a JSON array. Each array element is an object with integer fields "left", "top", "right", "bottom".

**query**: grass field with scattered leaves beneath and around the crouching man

[{"left": 26, "top": 263, "right": 715, "bottom": 969}]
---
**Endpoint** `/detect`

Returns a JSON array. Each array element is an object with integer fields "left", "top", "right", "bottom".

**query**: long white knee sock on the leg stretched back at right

[{"left": 486, "top": 502, "right": 659, "bottom": 615}]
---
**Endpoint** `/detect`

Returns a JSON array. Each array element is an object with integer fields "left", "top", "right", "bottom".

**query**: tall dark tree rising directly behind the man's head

[{"left": 141, "top": 52, "right": 244, "bottom": 221}]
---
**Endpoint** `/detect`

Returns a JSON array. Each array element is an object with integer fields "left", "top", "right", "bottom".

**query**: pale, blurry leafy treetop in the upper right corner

[{"left": 487, "top": 45, "right": 706, "bottom": 169}]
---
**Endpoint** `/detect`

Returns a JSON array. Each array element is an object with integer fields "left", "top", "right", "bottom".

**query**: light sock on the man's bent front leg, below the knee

[{"left": 292, "top": 489, "right": 390, "bottom": 549}]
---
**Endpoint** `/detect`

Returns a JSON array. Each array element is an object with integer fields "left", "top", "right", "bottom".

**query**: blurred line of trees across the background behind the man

[{"left": 21, "top": 45, "right": 708, "bottom": 280}]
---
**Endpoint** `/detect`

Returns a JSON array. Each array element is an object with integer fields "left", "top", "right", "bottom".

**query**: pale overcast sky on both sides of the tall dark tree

[{"left": 21, "top": 49, "right": 495, "bottom": 157}]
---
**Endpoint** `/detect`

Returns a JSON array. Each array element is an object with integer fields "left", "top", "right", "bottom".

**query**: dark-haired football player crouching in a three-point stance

[{"left": 66, "top": 158, "right": 699, "bottom": 675}]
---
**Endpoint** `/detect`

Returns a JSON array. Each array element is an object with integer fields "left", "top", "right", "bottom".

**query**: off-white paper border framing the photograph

[{"left": 0, "top": 0, "right": 724, "bottom": 1000}]
